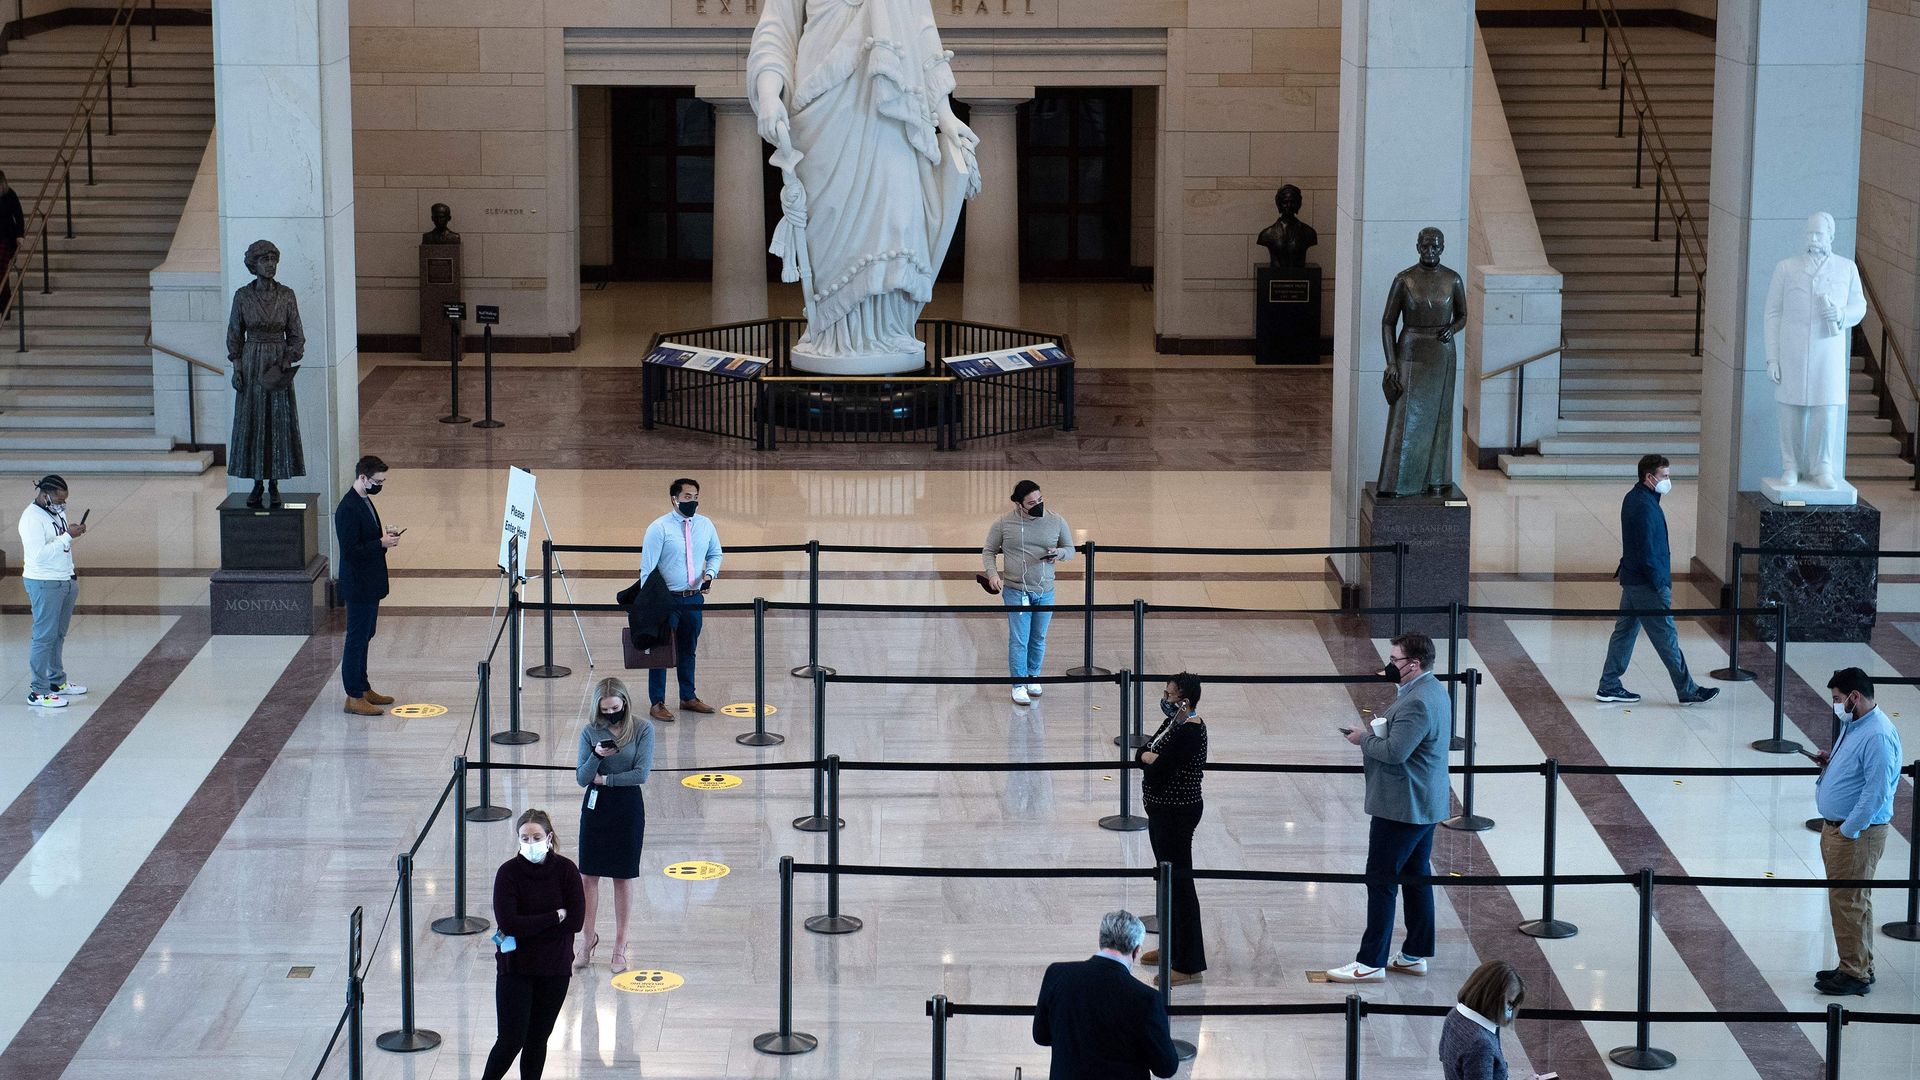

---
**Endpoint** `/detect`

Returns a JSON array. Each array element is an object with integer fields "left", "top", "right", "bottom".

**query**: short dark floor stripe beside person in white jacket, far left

[{"left": 0, "top": 607, "right": 209, "bottom": 878}]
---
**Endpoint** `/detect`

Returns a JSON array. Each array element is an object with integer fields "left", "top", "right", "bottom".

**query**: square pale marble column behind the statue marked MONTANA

[{"left": 213, "top": 0, "right": 360, "bottom": 567}]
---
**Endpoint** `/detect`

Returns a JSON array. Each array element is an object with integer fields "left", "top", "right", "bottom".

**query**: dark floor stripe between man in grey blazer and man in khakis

[{"left": 1471, "top": 617, "right": 1824, "bottom": 1080}]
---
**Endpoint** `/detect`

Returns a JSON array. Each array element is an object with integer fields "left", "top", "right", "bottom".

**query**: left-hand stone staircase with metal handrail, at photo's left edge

[{"left": 0, "top": 27, "right": 219, "bottom": 475}]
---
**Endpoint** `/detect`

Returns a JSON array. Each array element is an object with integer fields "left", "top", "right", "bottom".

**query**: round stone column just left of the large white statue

[{"left": 693, "top": 86, "right": 774, "bottom": 323}]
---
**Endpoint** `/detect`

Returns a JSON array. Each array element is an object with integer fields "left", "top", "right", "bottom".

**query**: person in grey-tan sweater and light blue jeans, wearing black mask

[{"left": 979, "top": 480, "right": 1073, "bottom": 705}]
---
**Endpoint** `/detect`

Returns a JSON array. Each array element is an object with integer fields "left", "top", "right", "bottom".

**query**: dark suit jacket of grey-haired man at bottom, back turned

[{"left": 1033, "top": 955, "right": 1181, "bottom": 1080}]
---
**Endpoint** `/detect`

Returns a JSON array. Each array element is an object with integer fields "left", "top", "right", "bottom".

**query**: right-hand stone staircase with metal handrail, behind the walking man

[{"left": 1482, "top": 27, "right": 1912, "bottom": 479}]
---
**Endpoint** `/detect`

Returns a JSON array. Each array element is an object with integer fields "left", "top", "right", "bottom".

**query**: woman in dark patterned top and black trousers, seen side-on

[{"left": 1139, "top": 673, "right": 1206, "bottom": 986}]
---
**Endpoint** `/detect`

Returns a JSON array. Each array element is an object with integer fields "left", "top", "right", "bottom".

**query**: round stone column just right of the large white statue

[{"left": 954, "top": 86, "right": 1033, "bottom": 327}]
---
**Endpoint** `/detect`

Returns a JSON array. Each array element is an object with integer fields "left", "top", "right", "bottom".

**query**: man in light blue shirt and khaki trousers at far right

[{"left": 1812, "top": 667, "right": 1901, "bottom": 997}]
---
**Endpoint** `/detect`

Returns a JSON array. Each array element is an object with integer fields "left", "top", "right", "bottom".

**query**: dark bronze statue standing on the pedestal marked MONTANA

[{"left": 227, "top": 240, "right": 307, "bottom": 507}]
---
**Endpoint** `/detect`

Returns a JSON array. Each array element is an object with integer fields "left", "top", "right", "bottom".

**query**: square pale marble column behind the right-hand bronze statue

[{"left": 1331, "top": 0, "right": 1473, "bottom": 582}]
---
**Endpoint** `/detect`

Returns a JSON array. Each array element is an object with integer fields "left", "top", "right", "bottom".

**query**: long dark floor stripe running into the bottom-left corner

[{"left": 0, "top": 636, "right": 338, "bottom": 1080}]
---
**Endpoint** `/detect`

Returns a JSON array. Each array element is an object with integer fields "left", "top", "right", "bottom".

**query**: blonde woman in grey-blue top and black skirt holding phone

[{"left": 574, "top": 678, "right": 653, "bottom": 972}]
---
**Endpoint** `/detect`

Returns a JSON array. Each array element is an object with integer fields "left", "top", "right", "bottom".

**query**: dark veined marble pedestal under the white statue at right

[{"left": 1734, "top": 492, "right": 1880, "bottom": 642}]
